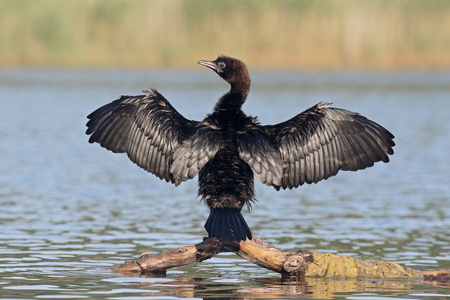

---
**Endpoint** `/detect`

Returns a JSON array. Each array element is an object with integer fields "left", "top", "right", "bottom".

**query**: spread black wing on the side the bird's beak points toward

[{"left": 86, "top": 90, "right": 220, "bottom": 185}]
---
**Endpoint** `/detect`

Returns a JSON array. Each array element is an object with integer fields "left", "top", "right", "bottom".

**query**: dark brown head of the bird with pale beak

[{"left": 198, "top": 55, "right": 250, "bottom": 88}]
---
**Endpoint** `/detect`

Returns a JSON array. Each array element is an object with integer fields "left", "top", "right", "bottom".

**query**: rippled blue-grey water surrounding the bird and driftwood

[{"left": 0, "top": 69, "right": 450, "bottom": 300}]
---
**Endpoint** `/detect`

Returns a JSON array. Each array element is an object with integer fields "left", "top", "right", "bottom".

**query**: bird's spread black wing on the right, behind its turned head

[{"left": 241, "top": 103, "right": 395, "bottom": 189}]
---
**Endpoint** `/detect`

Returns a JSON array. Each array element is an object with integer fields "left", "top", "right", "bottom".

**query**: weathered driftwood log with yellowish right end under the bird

[{"left": 114, "top": 236, "right": 450, "bottom": 282}]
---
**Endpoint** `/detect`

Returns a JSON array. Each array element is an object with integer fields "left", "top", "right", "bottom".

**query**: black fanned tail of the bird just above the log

[{"left": 205, "top": 208, "right": 252, "bottom": 242}]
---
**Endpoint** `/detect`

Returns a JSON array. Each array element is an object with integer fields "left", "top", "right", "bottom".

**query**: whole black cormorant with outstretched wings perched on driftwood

[{"left": 86, "top": 56, "right": 395, "bottom": 241}]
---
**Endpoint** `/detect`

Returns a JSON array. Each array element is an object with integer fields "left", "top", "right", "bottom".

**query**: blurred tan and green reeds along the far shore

[{"left": 0, "top": 0, "right": 450, "bottom": 69}]
